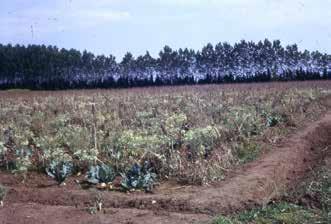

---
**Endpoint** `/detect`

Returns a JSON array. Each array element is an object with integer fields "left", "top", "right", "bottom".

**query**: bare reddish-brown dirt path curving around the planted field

[{"left": 0, "top": 112, "right": 331, "bottom": 224}]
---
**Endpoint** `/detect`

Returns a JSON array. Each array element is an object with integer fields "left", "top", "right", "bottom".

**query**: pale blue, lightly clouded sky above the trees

[{"left": 0, "top": 0, "right": 331, "bottom": 60}]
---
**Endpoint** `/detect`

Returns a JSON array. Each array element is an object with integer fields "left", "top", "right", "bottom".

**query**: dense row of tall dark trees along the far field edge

[{"left": 0, "top": 39, "right": 331, "bottom": 90}]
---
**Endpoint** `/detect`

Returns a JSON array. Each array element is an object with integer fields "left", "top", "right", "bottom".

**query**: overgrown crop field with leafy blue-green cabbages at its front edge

[{"left": 0, "top": 81, "right": 331, "bottom": 223}]
